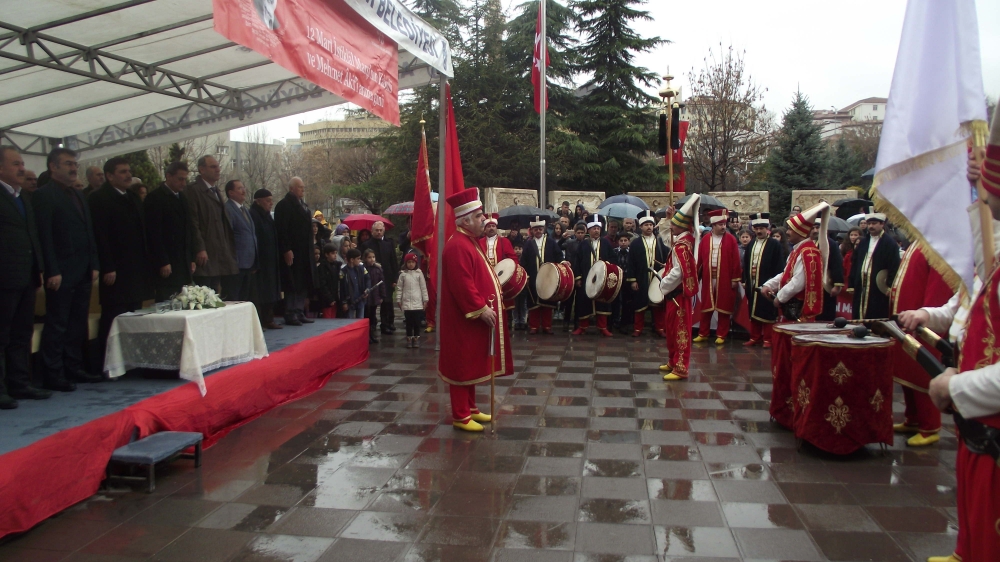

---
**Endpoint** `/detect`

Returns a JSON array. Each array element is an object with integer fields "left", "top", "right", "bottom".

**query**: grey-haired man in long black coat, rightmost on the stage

[{"left": 274, "top": 178, "right": 316, "bottom": 326}]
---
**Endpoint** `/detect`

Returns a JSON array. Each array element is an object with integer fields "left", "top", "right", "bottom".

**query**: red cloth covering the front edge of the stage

[{"left": 0, "top": 322, "right": 368, "bottom": 537}]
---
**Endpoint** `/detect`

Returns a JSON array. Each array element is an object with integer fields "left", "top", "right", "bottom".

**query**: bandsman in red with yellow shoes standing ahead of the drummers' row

[{"left": 660, "top": 193, "right": 701, "bottom": 381}]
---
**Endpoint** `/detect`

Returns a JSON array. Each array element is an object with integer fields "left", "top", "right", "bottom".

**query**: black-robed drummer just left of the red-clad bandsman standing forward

[{"left": 625, "top": 211, "right": 669, "bottom": 338}]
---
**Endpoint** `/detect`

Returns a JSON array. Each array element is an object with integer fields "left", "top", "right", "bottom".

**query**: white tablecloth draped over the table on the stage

[{"left": 104, "top": 302, "right": 267, "bottom": 396}]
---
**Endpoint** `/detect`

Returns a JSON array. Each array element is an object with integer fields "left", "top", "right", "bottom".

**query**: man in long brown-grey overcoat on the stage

[{"left": 184, "top": 156, "right": 240, "bottom": 298}]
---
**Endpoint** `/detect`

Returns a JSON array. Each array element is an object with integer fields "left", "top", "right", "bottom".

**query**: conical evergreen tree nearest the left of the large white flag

[{"left": 766, "top": 92, "right": 827, "bottom": 216}]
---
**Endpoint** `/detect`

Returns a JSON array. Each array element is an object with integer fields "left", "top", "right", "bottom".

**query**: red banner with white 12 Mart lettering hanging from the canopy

[{"left": 212, "top": 0, "right": 399, "bottom": 125}]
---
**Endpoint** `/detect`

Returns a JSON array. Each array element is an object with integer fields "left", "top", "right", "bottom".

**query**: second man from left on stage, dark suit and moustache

[{"left": 31, "top": 148, "right": 100, "bottom": 392}]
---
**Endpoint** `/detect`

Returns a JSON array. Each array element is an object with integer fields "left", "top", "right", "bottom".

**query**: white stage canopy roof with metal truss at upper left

[{"left": 0, "top": 0, "right": 451, "bottom": 159}]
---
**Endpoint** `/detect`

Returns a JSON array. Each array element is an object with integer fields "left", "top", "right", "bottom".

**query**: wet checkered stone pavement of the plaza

[{"left": 0, "top": 331, "right": 957, "bottom": 562}]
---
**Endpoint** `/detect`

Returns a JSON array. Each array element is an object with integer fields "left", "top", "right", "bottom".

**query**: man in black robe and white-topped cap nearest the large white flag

[{"left": 851, "top": 213, "right": 900, "bottom": 320}]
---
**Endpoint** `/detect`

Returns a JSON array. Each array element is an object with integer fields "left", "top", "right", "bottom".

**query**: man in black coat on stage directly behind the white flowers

[{"left": 142, "top": 162, "right": 195, "bottom": 301}]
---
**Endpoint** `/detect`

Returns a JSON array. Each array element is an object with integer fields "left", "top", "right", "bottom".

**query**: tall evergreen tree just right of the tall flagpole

[{"left": 571, "top": 0, "right": 666, "bottom": 195}]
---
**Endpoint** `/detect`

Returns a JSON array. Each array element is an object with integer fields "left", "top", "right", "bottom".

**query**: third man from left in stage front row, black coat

[{"left": 87, "top": 156, "right": 153, "bottom": 368}]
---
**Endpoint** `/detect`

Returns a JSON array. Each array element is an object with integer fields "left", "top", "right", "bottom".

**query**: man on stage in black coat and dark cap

[{"left": 250, "top": 189, "right": 281, "bottom": 330}]
